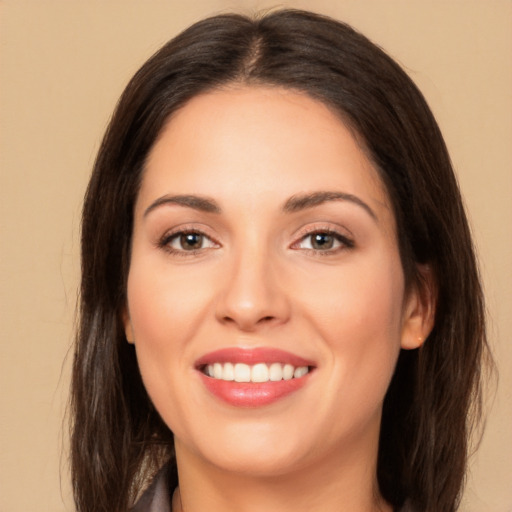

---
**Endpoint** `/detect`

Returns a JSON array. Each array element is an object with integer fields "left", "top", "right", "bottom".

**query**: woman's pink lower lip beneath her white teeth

[{"left": 200, "top": 372, "right": 309, "bottom": 407}]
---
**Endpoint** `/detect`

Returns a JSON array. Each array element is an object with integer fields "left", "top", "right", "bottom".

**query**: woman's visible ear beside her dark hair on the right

[{"left": 400, "top": 265, "right": 437, "bottom": 350}]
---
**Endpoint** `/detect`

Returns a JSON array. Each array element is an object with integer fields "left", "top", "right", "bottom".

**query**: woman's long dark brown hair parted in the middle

[{"left": 71, "top": 10, "right": 487, "bottom": 512}]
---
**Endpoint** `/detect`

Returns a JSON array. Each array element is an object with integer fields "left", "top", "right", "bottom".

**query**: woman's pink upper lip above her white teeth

[{"left": 196, "top": 347, "right": 315, "bottom": 368}]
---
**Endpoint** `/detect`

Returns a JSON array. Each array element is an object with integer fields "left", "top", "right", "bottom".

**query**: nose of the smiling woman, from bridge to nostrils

[{"left": 216, "top": 251, "right": 290, "bottom": 332}]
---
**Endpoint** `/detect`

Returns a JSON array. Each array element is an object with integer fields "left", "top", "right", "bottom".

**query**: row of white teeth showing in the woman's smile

[{"left": 204, "top": 363, "right": 309, "bottom": 382}]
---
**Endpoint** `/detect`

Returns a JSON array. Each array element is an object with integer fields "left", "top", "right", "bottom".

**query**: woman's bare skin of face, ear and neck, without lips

[{"left": 124, "top": 86, "right": 432, "bottom": 512}]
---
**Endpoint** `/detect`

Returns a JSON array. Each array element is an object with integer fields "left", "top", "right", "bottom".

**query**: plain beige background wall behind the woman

[{"left": 0, "top": 0, "right": 512, "bottom": 512}]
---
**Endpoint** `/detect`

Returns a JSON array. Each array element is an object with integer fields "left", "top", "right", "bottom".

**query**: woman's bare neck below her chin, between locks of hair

[{"left": 173, "top": 440, "right": 392, "bottom": 512}]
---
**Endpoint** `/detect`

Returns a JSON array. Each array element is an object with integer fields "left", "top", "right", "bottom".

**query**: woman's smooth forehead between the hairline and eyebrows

[{"left": 139, "top": 86, "right": 388, "bottom": 216}]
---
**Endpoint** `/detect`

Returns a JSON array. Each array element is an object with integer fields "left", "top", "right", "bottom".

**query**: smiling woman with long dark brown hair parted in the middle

[{"left": 72, "top": 10, "right": 486, "bottom": 512}]
